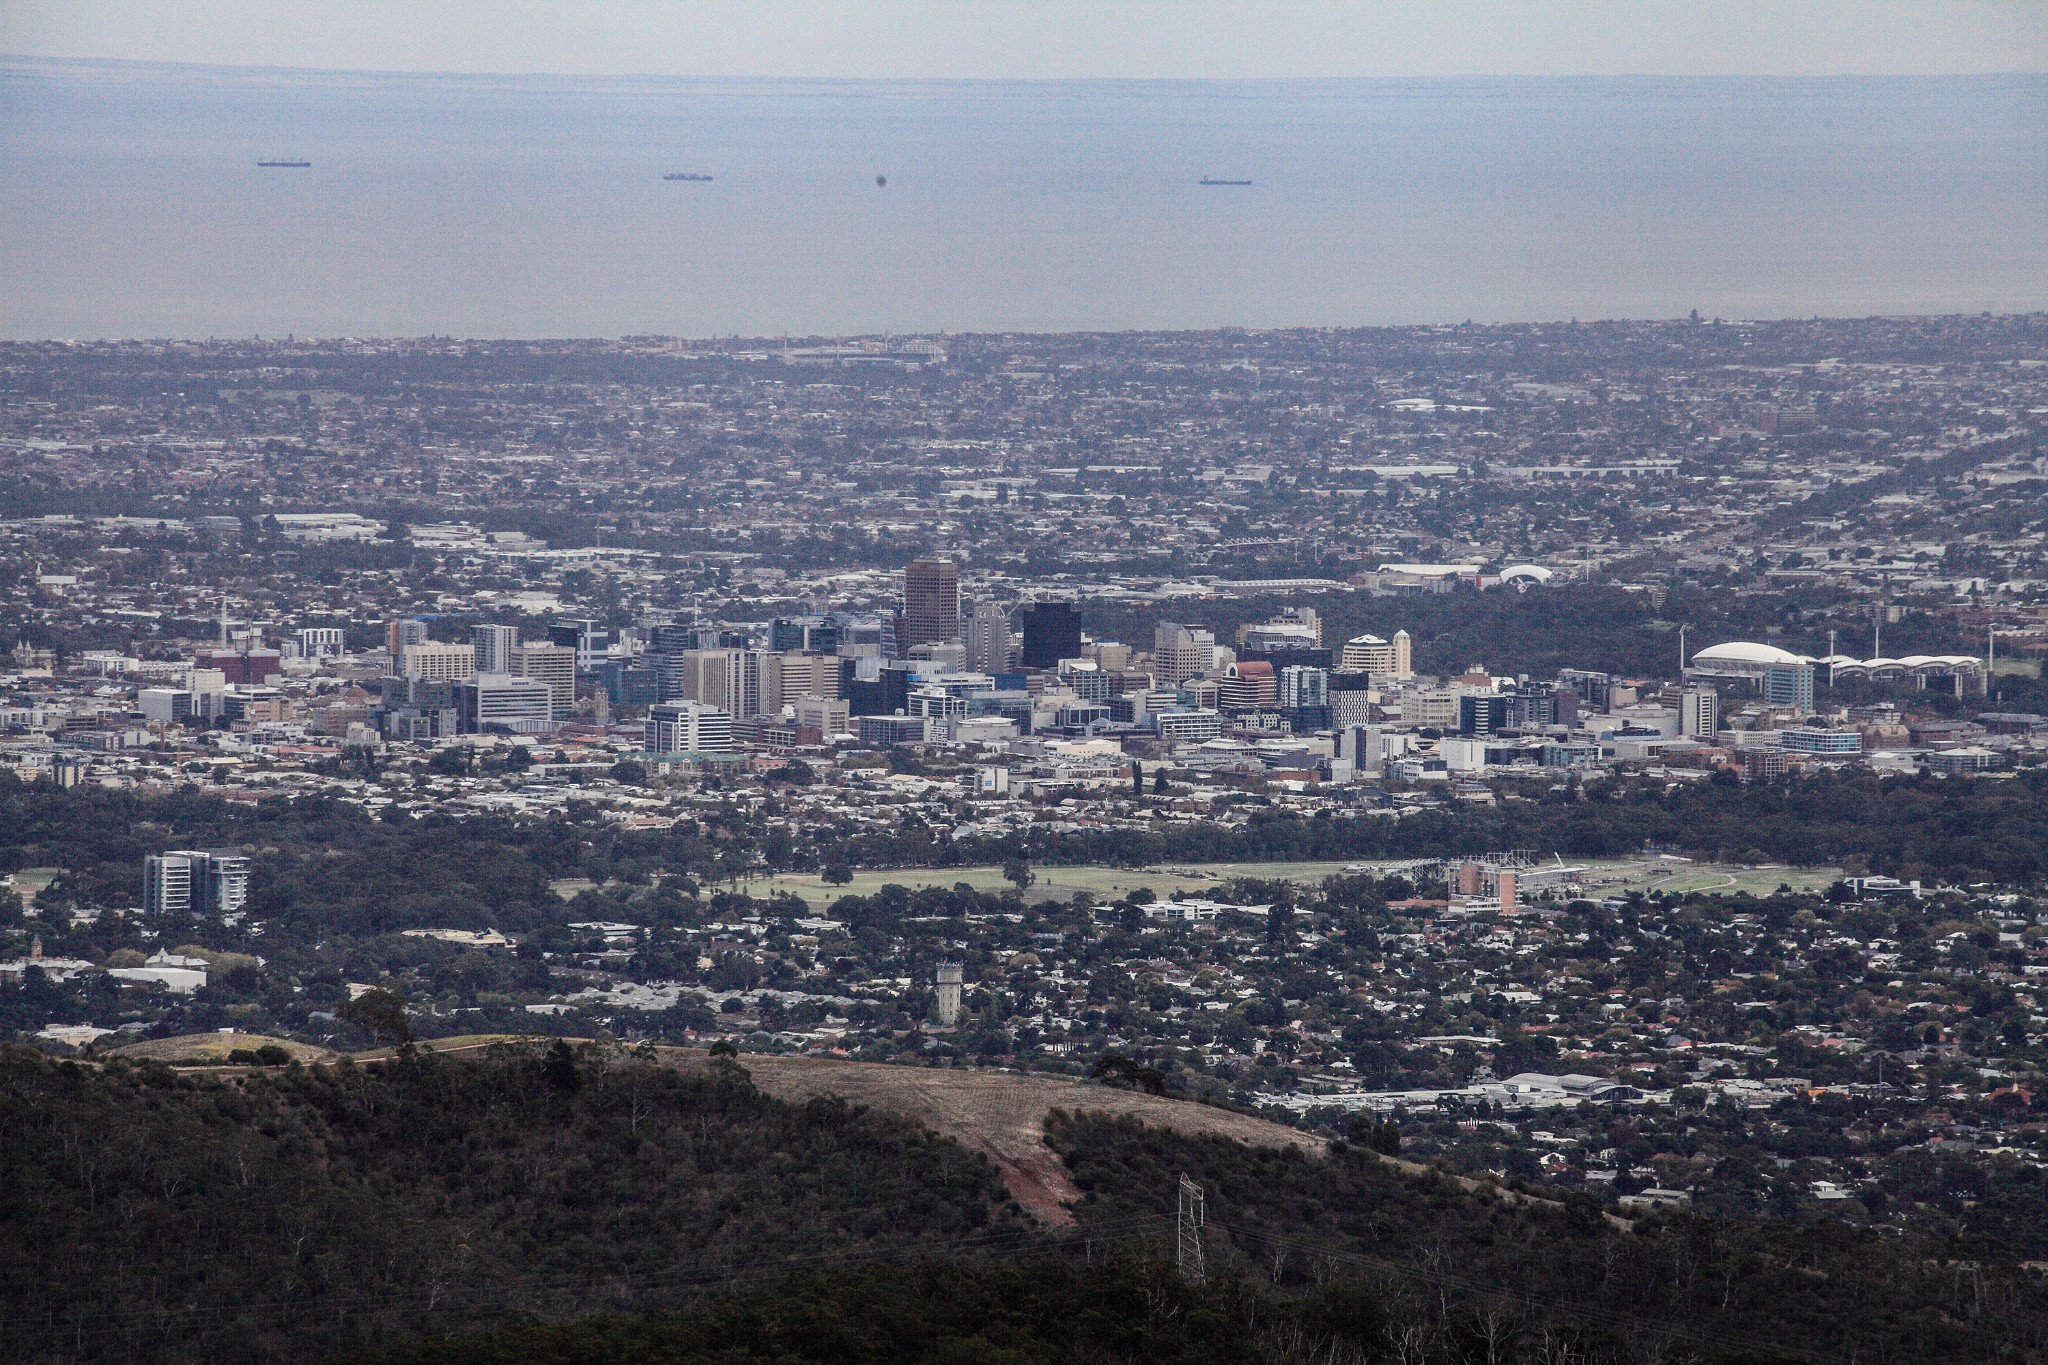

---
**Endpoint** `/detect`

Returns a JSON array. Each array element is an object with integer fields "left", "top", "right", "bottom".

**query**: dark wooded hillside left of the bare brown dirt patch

[{"left": 0, "top": 1044, "right": 1024, "bottom": 1361}]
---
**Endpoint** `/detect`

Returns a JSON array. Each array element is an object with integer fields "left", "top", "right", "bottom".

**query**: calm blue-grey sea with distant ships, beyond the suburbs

[{"left": 0, "top": 59, "right": 2048, "bottom": 338}]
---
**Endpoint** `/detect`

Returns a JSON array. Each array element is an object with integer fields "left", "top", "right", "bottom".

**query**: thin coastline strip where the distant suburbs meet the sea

[{"left": 0, "top": 307, "right": 2048, "bottom": 348}]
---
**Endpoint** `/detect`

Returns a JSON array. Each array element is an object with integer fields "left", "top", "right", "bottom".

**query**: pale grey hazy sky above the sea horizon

[{"left": 0, "top": 0, "right": 2048, "bottom": 78}]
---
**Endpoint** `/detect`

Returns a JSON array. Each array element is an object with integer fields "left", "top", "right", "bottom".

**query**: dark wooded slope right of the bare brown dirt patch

[{"left": 1049, "top": 1115, "right": 2048, "bottom": 1363}]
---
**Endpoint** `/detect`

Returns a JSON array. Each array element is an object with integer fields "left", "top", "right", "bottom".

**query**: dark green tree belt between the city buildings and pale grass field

[{"left": 0, "top": 769, "right": 2048, "bottom": 957}]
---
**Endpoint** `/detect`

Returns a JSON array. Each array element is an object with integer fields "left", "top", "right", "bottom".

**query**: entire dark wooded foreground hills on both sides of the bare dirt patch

[{"left": 0, "top": 1044, "right": 2048, "bottom": 1365}]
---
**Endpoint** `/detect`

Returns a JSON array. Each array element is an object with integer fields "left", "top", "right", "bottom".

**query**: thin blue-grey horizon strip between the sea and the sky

[{"left": 0, "top": 51, "right": 2048, "bottom": 86}]
